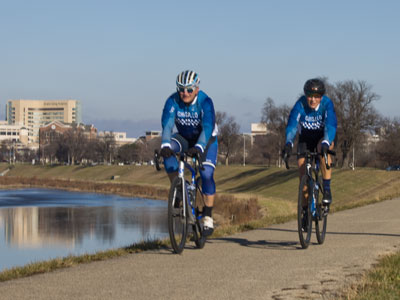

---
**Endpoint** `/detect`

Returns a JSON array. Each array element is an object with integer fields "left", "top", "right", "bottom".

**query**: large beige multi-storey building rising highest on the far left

[{"left": 6, "top": 99, "right": 82, "bottom": 146}]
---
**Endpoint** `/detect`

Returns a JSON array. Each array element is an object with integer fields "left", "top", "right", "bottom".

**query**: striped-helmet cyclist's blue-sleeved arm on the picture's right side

[{"left": 195, "top": 97, "right": 215, "bottom": 152}]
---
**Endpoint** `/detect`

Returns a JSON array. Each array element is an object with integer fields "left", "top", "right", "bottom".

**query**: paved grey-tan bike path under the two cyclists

[{"left": 0, "top": 199, "right": 400, "bottom": 300}]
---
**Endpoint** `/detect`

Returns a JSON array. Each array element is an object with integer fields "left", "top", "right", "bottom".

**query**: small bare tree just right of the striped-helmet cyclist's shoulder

[{"left": 215, "top": 111, "right": 240, "bottom": 165}]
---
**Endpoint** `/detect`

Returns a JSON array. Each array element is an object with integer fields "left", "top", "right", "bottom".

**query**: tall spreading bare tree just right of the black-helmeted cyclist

[{"left": 328, "top": 80, "right": 379, "bottom": 167}]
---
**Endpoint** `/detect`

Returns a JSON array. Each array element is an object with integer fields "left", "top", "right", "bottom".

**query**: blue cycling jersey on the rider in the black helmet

[{"left": 286, "top": 96, "right": 337, "bottom": 145}]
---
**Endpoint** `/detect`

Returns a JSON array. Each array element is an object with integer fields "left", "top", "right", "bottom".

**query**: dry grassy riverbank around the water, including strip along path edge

[{"left": 0, "top": 165, "right": 400, "bottom": 290}]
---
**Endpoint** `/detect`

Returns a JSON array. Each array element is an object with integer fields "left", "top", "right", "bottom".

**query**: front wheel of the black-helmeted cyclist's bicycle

[{"left": 297, "top": 175, "right": 312, "bottom": 249}]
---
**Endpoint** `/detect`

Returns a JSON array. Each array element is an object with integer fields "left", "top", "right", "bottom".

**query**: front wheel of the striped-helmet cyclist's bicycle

[{"left": 168, "top": 177, "right": 188, "bottom": 254}]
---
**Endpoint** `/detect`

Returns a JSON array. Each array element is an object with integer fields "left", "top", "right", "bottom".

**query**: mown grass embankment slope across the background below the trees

[{"left": 0, "top": 164, "right": 400, "bottom": 213}]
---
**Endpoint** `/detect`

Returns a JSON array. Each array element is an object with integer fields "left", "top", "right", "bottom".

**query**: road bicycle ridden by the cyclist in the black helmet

[{"left": 284, "top": 150, "right": 336, "bottom": 249}]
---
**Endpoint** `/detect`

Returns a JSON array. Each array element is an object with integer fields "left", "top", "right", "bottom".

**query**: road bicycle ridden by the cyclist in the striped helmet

[{"left": 154, "top": 150, "right": 206, "bottom": 254}]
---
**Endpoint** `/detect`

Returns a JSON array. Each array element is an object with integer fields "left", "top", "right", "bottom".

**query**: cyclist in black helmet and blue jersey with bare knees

[{"left": 282, "top": 78, "right": 337, "bottom": 210}]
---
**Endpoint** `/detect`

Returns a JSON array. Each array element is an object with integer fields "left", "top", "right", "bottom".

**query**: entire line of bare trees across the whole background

[{"left": 0, "top": 78, "right": 400, "bottom": 168}]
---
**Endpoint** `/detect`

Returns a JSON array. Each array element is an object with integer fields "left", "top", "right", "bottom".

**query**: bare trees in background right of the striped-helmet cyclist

[{"left": 219, "top": 78, "right": 400, "bottom": 168}]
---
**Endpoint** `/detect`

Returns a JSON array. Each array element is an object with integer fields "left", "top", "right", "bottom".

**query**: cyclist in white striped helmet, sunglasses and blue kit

[{"left": 160, "top": 70, "right": 218, "bottom": 236}]
